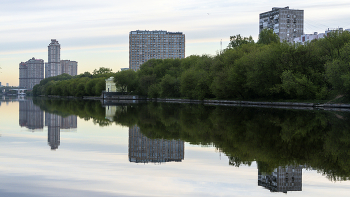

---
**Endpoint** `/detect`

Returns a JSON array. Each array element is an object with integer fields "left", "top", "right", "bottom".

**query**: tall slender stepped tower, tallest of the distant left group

[{"left": 45, "top": 39, "right": 62, "bottom": 78}]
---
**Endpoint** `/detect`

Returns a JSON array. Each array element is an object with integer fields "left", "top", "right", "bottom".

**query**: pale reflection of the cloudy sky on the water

[{"left": 0, "top": 103, "right": 350, "bottom": 197}]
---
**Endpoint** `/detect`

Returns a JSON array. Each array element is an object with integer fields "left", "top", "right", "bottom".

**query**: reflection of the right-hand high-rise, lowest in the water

[{"left": 258, "top": 166, "right": 302, "bottom": 193}]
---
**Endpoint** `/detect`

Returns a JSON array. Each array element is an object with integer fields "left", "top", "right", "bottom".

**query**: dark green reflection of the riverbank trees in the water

[{"left": 34, "top": 99, "right": 350, "bottom": 180}]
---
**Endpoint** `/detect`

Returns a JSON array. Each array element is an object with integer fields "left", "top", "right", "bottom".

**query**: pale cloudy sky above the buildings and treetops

[{"left": 0, "top": 0, "right": 350, "bottom": 86}]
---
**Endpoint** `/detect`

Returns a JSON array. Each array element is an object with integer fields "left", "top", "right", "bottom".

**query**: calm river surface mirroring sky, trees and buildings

[{"left": 0, "top": 97, "right": 350, "bottom": 197}]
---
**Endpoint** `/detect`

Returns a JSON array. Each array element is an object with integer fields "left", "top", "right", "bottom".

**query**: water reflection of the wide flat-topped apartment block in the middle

[{"left": 129, "top": 126, "right": 184, "bottom": 163}]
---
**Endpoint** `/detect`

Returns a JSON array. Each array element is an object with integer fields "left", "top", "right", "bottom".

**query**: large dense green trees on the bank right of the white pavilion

[{"left": 115, "top": 30, "right": 350, "bottom": 100}]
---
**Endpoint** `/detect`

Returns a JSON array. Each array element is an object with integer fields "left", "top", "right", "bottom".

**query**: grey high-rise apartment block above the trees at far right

[{"left": 259, "top": 7, "right": 304, "bottom": 42}]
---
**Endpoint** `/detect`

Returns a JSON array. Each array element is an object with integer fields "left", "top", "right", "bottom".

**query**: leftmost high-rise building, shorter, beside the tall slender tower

[{"left": 19, "top": 57, "right": 44, "bottom": 89}]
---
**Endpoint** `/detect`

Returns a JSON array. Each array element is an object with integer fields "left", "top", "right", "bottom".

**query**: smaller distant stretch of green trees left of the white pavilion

[{"left": 33, "top": 67, "right": 114, "bottom": 97}]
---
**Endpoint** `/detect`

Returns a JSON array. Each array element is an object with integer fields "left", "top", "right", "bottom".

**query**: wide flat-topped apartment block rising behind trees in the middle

[{"left": 129, "top": 30, "right": 185, "bottom": 70}]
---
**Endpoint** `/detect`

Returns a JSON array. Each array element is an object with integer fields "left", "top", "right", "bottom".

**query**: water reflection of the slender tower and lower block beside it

[{"left": 45, "top": 113, "right": 77, "bottom": 150}]
